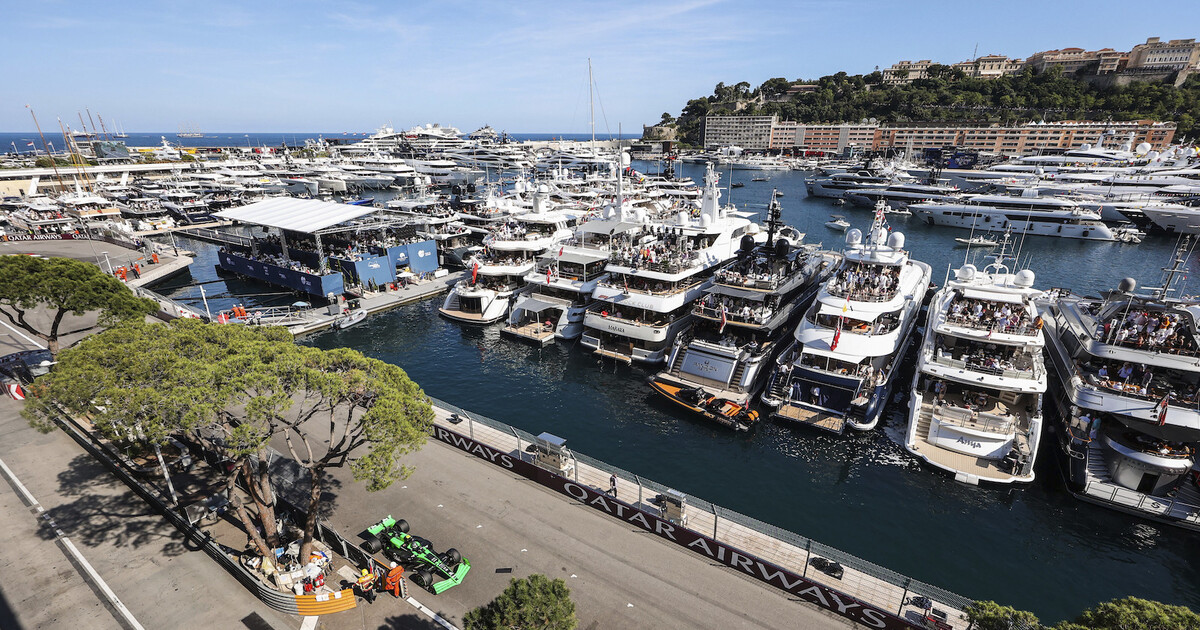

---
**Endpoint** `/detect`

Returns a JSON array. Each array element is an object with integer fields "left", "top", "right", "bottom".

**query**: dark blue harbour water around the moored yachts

[{"left": 142, "top": 157, "right": 1200, "bottom": 623}]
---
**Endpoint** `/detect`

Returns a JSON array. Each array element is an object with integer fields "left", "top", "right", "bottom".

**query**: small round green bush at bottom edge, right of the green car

[{"left": 462, "top": 574, "right": 580, "bottom": 630}]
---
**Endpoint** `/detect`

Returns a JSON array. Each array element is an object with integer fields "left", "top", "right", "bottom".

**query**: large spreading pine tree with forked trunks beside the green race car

[{"left": 25, "top": 319, "right": 433, "bottom": 556}]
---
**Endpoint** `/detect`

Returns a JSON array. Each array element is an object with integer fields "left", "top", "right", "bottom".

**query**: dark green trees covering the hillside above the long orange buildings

[{"left": 662, "top": 65, "right": 1200, "bottom": 145}]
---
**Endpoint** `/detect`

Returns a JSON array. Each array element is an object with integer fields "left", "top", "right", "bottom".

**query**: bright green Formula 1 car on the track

[{"left": 362, "top": 515, "right": 470, "bottom": 593}]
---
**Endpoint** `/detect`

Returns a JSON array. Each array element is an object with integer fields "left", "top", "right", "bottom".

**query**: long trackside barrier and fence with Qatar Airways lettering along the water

[{"left": 431, "top": 398, "right": 973, "bottom": 629}]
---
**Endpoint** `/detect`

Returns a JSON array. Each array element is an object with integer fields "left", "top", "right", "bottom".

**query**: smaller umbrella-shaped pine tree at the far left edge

[{"left": 0, "top": 256, "right": 158, "bottom": 354}]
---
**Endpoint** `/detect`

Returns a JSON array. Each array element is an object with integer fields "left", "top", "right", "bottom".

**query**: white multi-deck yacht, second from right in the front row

[{"left": 905, "top": 235, "right": 1046, "bottom": 485}]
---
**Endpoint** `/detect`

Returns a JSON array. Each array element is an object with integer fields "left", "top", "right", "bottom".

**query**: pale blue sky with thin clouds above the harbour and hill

[{"left": 0, "top": 0, "right": 1200, "bottom": 134}]
